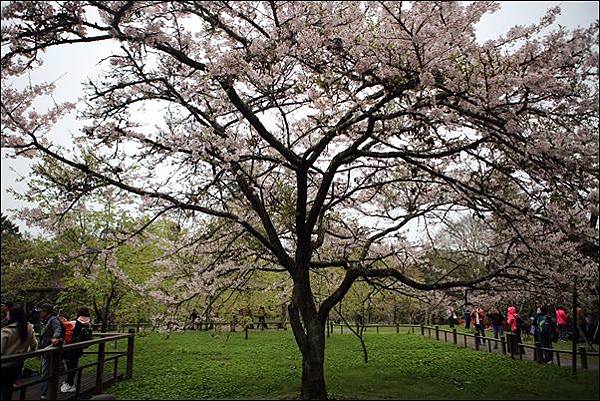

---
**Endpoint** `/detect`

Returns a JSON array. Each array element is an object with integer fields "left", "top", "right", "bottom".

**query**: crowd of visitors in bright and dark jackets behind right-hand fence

[{"left": 448, "top": 305, "right": 594, "bottom": 363}]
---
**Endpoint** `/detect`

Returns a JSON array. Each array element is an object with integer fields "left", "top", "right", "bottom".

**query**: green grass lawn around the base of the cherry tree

[{"left": 109, "top": 331, "right": 598, "bottom": 399}]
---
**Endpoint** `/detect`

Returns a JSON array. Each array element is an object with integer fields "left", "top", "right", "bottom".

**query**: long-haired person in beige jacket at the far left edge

[{"left": 0, "top": 306, "right": 37, "bottom": 400}]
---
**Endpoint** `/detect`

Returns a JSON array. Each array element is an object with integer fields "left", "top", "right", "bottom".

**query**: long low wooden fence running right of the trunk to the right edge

[{"left": 327, "top": 322, "right": 599, "bottom": 372}]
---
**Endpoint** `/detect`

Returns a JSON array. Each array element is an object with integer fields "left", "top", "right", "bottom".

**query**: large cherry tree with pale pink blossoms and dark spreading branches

[{"left": 1, "top": 1, "right": 598, "bottom": 399}]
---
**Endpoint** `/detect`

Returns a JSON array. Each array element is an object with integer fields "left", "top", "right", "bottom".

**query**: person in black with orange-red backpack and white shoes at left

[{"left": 60, "top": 306, "right": 93, "bottom": 393}]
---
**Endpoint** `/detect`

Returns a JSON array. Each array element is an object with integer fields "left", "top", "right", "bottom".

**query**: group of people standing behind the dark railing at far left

[{"left": 0, "top": 303, "right": 92, "bottom": 400}]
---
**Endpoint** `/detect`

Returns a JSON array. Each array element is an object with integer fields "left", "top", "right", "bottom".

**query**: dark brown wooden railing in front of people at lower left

[{"left": 1, "top": 331, "right": 135, "bottom": 400}]
